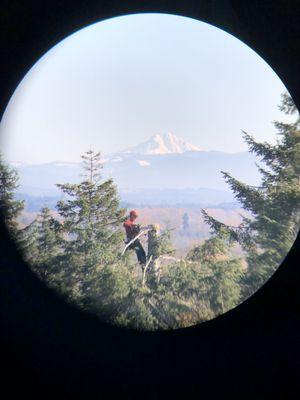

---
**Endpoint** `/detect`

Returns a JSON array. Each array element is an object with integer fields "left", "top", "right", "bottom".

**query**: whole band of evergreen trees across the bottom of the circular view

[{"left": 0, "top": 95, "right": 300, "bottom": 330}]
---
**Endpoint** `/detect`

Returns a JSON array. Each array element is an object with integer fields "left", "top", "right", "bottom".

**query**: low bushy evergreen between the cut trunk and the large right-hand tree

[{"left": 141, "top": 233, "right": 243, "bottom": 329}]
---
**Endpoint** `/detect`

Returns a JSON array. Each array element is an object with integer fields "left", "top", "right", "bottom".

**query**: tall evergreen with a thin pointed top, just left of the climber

[{"left": 57, "top": 150, "right": 125, "bottom": 306}]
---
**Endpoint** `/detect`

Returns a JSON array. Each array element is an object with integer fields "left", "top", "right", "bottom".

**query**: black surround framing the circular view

[{"left": 0, "top": 0, "right": 300, "bottom": 399}]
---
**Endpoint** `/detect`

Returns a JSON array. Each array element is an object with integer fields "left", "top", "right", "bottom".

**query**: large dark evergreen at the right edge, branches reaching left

[{"left": 203, "top": 94, "right": 300, "bottom": 296}]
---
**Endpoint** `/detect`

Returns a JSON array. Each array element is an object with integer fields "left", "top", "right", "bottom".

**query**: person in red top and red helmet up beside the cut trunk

[{"left": 123, "top": 210, "right": 147, "bottom": 268}]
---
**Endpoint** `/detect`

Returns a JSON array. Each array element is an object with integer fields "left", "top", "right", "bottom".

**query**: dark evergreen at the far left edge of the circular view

[{"left": 0, "top": 154, "right": 24, "bottom": 239}]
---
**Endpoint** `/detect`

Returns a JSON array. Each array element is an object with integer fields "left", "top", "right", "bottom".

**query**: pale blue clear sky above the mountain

[{"left": 0, "top": 14, "right": 286, "bottom": 163}]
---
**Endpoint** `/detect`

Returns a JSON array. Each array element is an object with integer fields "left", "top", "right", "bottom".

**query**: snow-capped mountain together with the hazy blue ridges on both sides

[{"left": 10, "top": 133, "right": 260, "bottom": 202}]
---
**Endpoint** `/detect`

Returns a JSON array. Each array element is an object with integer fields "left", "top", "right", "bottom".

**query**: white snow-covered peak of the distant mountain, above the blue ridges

[{"left": 121, "top": 132, "right": 201, "bottom": 155}]
